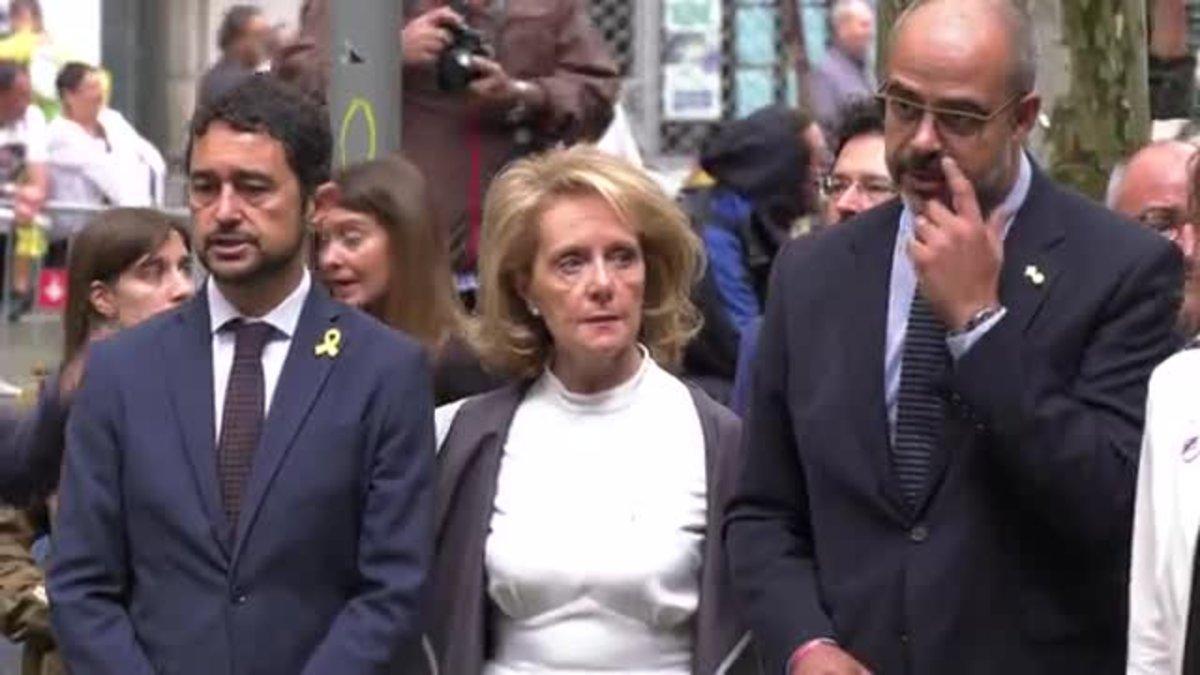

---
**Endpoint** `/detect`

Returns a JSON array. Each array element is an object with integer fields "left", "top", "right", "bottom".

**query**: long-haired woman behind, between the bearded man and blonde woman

[{"left": 313, "top": 157, "right": 500, "bottom": 405}]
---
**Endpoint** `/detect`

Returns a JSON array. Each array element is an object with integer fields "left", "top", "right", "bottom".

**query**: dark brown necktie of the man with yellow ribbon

[{"left": 217, "top": 319, "right": 275, "bottom": 532}]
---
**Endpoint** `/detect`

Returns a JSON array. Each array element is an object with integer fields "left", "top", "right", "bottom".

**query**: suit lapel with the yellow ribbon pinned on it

[{"left": 233, "top": 285, "right": 343, "bottom": 561}]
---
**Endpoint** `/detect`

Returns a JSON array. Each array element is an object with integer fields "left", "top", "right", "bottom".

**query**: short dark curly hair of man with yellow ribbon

[{"left": 187, "top": 73, "right": 334, "bottom": 198}]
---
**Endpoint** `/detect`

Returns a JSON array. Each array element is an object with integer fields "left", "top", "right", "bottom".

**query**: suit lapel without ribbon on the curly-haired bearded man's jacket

[{"left": 163, "top": 289, "right": 229, "bottom": 556}]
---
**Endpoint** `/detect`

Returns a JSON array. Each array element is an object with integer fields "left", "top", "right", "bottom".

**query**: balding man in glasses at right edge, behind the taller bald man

[{"left": 1108, "top": 141, "right": 1200, "bottom": 340}]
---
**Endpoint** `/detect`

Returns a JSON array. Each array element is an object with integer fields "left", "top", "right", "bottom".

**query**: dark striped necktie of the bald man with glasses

[{"left": 892, "top": 292, "right": 950, "bottom": 508}]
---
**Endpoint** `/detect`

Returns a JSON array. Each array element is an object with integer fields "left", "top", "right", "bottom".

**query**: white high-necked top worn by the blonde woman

[{"left": 470, "top": 352, "right": 707, "bottom": 675}]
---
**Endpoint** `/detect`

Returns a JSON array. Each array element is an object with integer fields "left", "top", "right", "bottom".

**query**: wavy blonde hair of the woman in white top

[{"left": 472, "top": 145, "right": 704, "bottom": 378}]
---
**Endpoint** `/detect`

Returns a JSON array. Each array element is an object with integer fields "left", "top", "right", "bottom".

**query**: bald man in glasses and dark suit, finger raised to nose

[{"left": 725, "top": 0, "right": 1182, "bottom": 675}]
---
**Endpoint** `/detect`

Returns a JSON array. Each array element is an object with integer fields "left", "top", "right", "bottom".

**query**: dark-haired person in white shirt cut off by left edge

[{"left": 0, "top": 61, "right": 47, "bottom": 321}]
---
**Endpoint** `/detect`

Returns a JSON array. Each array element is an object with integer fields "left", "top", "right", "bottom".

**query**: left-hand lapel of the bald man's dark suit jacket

[{"left": 846, "top": 201, "right": 906, "bottom": 515}]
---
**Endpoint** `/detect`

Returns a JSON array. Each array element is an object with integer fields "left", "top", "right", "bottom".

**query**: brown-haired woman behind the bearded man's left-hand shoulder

[{"left": 0, "top": 209, "right": 194, "bottom": 675}]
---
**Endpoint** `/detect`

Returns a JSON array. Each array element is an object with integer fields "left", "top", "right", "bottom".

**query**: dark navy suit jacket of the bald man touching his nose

[{"left": 725, "top": 172, "right": 1182, "bottom": 675}]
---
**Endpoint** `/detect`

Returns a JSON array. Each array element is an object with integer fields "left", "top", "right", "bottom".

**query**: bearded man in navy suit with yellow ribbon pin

[{"left": 49, "top": 76, "right": 433, "bottom": 675}]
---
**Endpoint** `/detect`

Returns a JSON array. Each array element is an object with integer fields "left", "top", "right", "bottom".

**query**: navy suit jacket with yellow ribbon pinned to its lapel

[{"left": 49, "top": 287, "right": 433, "bottom": 675}]
